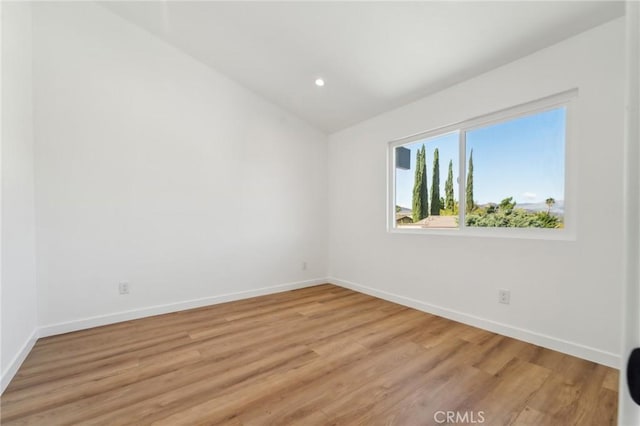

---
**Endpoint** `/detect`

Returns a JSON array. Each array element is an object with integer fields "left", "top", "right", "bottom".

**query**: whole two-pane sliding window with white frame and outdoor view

[{"left": 389, "top": 90, "right": 577, "bottom": 236}]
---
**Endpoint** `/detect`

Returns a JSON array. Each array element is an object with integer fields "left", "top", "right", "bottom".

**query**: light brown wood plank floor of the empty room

[{"left": 1, "top": 285, "right": 618, "bottom": 426}]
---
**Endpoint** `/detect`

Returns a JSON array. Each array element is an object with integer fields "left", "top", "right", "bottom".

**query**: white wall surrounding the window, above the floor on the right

[{"left": 329, "top": 19, "right": 624, "bottom": 367}]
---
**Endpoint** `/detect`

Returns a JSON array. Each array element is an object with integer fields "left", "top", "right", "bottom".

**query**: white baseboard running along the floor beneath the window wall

[{"left": 327, "top": 277, "right": 621, "bottom": 369}]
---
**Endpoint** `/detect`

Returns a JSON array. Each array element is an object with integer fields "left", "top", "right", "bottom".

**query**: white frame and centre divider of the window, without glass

[{"left": 387, "top": 89, "right": 578, "bottom": 240}]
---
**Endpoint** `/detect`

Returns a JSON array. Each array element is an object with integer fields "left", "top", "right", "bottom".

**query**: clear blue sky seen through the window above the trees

[{"left": 396, "top": 108, "right": 566, "bottom": 208}]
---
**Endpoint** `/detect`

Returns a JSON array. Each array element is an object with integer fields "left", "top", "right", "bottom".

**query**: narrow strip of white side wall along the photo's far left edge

[{"left": 0, "top": 2, "right": 37, "bottom": 390}]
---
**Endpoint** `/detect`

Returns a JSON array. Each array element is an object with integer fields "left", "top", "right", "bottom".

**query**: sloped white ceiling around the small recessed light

[{"left": 102, "top": 1, "right": 624, "bottom": 133}]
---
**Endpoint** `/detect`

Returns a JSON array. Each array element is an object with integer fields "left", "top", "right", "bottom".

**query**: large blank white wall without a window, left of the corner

[{"left": 34, "top": 3, "right": 327, "bottom": 334}]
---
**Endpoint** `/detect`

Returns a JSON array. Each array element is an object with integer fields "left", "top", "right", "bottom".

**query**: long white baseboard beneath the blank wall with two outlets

[{"left": 40, "top": 278, "right": 327, "bottom": 337}]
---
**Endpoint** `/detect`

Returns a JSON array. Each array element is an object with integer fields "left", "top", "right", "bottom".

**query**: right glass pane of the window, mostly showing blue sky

[{"left": 465, "top": 107, "right": 566, "bottom": 228}]
